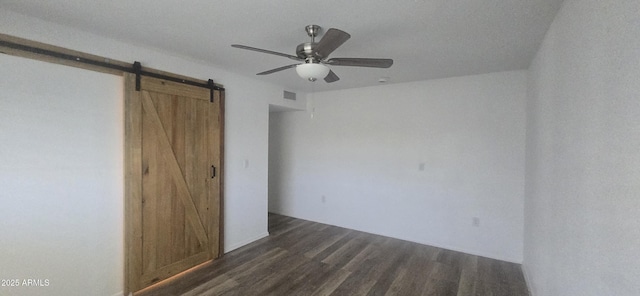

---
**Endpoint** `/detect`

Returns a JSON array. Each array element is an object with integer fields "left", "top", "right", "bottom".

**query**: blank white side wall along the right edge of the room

[{"left": 523, "top": 0, "right": 640, "bottom": 296}]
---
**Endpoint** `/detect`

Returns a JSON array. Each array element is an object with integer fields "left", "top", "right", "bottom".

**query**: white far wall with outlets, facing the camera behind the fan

[{"left": 269, "top": 71, "right": 526, "bottom": 262}]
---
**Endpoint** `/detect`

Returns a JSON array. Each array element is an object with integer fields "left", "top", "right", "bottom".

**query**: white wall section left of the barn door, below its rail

[{"left": 0, "top": 55, "right": 124, "bottom": 295}]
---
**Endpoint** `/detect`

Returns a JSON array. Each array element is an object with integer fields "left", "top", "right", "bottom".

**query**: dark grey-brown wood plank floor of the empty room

[{"left": 137, "top": 214, "right": 529, "bottom": 296}]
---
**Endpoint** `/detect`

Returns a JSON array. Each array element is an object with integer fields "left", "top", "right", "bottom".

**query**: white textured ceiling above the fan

[{"left": 0, "top": 0, "right": 562, "bottom": 91}]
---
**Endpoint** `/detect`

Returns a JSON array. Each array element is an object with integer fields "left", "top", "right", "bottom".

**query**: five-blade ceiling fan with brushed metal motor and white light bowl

[{"left": 231, "top": 25, "right": 393, "bottom": 83}]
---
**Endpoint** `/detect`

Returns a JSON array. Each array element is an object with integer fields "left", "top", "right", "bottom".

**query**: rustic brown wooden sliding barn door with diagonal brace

[{"left": 125, "top": 75, "right": 223, "bottom": 292}]
